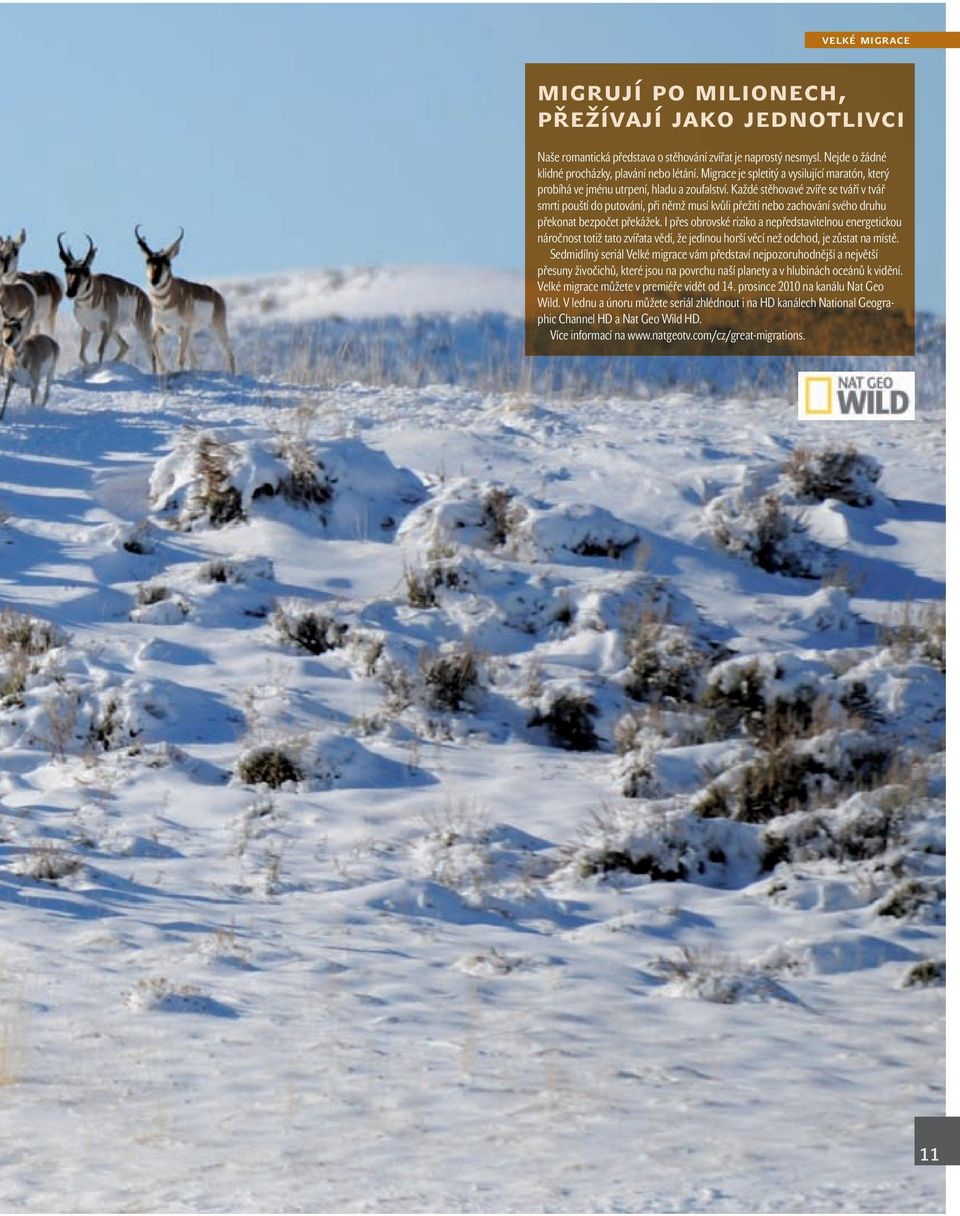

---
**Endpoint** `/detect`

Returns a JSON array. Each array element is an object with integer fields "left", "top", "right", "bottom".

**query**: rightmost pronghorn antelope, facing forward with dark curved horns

[{"left": 134, "top": 224, "right": 236, "bottom": 373}]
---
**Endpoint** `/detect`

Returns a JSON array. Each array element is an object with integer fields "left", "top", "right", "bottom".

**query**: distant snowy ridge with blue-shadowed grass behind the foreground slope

[{"left": 212, "top": 266, "right": 944, "bottom": 401}]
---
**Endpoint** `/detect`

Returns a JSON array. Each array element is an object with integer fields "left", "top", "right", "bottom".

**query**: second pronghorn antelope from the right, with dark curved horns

[{"left": 57, "top": 232, "right": 157, "bottom": 371}]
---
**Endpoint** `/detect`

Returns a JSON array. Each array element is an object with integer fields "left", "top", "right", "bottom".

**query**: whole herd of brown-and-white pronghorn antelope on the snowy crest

[{"left": 0, "top": 224, "right": 236, "bottom": 420}]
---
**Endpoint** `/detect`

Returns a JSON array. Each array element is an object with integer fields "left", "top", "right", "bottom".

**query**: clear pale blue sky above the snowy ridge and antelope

[{"left": 0, "top": 4, "right": 944, "bottom": 311}]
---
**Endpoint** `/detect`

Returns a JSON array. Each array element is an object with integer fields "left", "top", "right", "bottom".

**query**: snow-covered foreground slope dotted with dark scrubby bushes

[{"left": 0, "top": 271, "right": 944, "bottom": 1211}]
